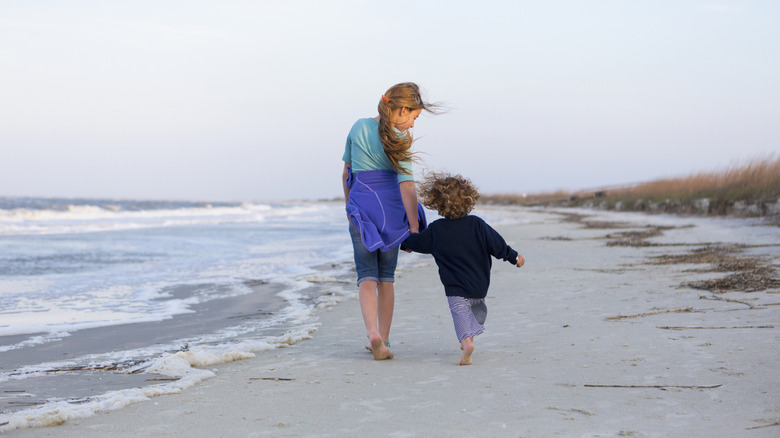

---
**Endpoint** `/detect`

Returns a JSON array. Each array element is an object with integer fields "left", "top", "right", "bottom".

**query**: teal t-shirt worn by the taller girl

[{"left": 341, "top": 118, "right": 414, "bottom": 183}]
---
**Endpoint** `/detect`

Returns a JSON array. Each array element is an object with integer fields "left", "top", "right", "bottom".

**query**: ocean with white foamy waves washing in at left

[{"left": 0, "top": 198, "right": 356, "bottom": 432}]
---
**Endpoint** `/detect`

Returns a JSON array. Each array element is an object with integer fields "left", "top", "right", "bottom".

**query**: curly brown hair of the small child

[{"left": 418, "top": 172, "right": 479, "bottom": 219}]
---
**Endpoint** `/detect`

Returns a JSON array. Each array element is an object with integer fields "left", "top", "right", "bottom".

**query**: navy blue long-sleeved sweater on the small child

[{"left": 402, "top": 216, "right": 517, "bottom": 298}]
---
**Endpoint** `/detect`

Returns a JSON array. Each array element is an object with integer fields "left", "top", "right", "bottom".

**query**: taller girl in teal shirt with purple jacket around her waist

[{"left": 342, "top": 82, "right": 436, "bottom": 360}]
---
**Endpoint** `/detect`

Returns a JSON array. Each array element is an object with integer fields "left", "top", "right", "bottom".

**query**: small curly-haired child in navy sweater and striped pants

[{"left": 402, "top": 173, "right": 525, "bottom": 365}]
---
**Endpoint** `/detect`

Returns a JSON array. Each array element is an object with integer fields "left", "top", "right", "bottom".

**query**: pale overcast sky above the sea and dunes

[{"left": 0, "top": 0, "right": 780, "bottom": 200}]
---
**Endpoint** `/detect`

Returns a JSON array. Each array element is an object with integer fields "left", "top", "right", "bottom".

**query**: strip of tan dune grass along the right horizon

[{"left": 481, "top": 154, "right": 780, "bottom": 216}]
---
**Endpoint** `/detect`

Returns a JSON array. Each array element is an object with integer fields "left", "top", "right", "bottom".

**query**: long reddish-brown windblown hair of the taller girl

[{"left": 378, "top": 82, "right": 437, "bottom": 175}]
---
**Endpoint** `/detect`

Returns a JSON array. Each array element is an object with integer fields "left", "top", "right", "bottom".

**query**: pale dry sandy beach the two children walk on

[{"left": 7, "top": 210, "right": 780, "bottom": 437}]
